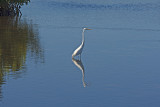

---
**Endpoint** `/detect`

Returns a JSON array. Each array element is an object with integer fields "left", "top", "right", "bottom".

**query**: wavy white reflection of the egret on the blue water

[{"left": 72, "top": 58, "right": 87, "bottom": 87}]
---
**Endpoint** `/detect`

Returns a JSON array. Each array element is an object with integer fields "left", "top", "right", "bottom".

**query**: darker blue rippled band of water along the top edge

[{"left": 49, "top": 1, "right": 160, "bottom": 11}]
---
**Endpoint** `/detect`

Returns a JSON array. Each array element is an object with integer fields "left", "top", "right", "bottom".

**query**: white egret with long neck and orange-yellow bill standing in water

[{"left": 72, "top": 28, "right": 91, "bottom": 58}]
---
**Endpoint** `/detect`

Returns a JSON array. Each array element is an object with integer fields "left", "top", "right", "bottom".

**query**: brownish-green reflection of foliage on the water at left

[{"left": 0, "top": 17, "right": 44, "bottom": 98}]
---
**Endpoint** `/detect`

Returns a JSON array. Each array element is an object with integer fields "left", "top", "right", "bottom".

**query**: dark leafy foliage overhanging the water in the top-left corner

[{"left": 0, "top": 0, "right": 30, "bottom": 16}]
